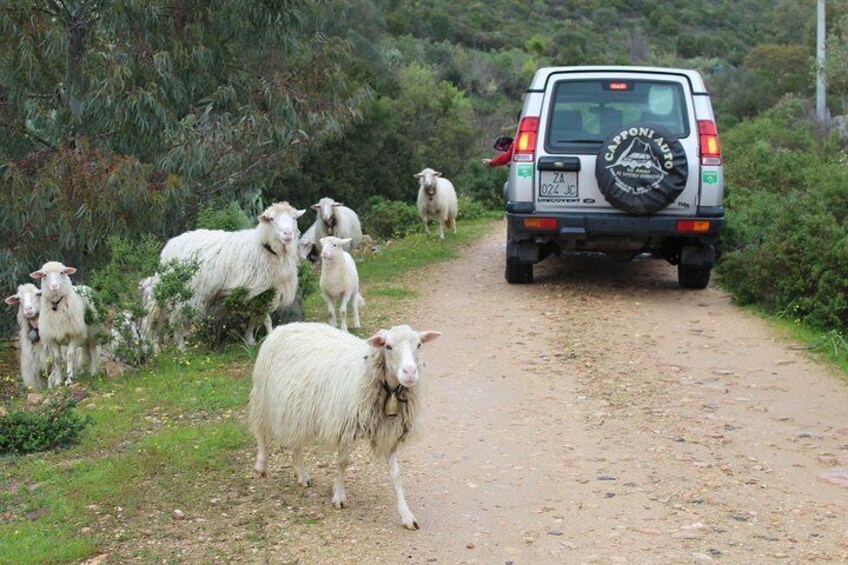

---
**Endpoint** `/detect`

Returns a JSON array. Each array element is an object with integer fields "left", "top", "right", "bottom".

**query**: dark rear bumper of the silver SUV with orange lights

[{"left": 506, "top": 211, "right": 724, "bottom": 244}]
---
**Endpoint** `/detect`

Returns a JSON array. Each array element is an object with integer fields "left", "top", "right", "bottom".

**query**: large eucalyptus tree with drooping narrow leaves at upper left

[{"left": 0, "top": 0, "right": 370, "bottom": 334}]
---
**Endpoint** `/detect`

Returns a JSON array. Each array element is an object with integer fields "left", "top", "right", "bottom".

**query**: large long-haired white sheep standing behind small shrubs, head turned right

[{"left": 153, "top": 198, "right": 305, "bottom": 351}]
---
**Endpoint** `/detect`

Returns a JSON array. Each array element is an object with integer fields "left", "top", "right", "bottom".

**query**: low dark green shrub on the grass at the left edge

[{"left": 0, "top": 396, "right": 92, "bottom": 454}]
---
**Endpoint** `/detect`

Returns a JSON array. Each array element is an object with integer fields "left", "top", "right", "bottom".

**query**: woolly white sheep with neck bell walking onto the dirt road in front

[{"left": 249, "top": 323, "right": 442, "bottom": 530}]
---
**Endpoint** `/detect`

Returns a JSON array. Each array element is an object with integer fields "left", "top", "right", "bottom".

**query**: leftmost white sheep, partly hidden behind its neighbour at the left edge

[{"left": 6, "top": 283, "right": 47, "bottom": 390}]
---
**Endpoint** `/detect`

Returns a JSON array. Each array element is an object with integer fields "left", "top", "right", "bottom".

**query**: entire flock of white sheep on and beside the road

[{"left": 6, "top": 168, "right": 457, "bottom": 530}]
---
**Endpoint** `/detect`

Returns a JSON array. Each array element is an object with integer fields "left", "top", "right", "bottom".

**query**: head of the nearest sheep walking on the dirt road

[{"left": 367, "top": 326, "right": 442, "bottom": 388}]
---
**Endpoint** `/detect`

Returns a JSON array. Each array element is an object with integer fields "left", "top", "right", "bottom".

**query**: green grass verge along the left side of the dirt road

[{"left": 0, "top": 218, "right": 500, "bottom": 565}]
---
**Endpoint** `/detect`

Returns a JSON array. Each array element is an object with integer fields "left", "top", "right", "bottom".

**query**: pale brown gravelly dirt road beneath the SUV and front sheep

[{"left": 245, "top": 223, "right": 848, "bottom": 565}]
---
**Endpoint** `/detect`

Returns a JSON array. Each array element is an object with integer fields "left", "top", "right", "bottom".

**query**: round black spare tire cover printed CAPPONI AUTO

[{"left": 595, "top": 124, "right": 689, "bottom": 214}]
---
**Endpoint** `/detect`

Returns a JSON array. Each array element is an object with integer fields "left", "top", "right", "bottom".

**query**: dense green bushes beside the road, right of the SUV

[{"left": 719, "top": 100, "right": 848, "bottom": 332}]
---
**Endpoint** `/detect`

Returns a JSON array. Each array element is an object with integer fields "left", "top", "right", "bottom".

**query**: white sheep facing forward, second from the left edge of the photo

[{"left": 30, "top": 261, "right": 100, "bottom": 387}]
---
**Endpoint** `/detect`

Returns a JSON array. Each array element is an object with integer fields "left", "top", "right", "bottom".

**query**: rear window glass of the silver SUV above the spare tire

[{"left": 545, "top": 79, "right": 689, "bottom": 153}]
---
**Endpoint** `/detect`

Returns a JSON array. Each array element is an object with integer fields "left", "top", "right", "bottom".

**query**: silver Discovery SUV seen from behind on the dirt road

[{"left": 499, "top": 66, "right": 724, "bottom": 289}]
